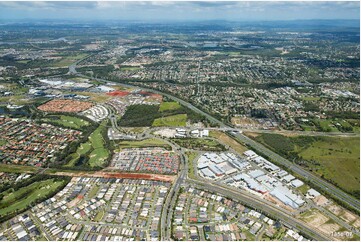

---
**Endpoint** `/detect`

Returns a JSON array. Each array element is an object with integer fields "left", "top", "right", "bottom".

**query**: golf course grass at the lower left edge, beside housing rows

[{"left": 0, "top": 179, "right": 65, "bottom": 217}]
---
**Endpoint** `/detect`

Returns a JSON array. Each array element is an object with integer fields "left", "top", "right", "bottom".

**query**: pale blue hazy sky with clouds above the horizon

[{"left": 0, "top": 1, "right": 360, "bottom": 21}]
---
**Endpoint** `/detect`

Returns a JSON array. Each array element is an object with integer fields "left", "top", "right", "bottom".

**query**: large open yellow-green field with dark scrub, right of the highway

[{"left": 256, "top": 134, "right": 360, "bottom": 194}]
